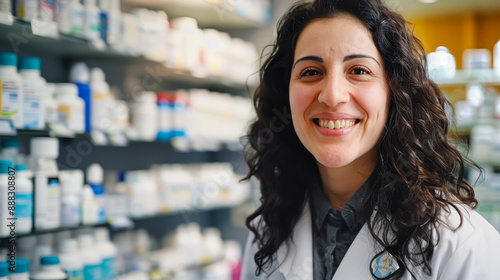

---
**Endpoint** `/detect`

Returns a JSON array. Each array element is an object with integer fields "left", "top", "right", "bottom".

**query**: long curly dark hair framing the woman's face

[{"left": 244, "top": 0, "right": 477, "bottom": 279}]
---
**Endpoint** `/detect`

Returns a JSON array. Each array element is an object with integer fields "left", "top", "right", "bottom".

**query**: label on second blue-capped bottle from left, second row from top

[{"left": 23, "top": 81, "right": 42, "bottom": 129}]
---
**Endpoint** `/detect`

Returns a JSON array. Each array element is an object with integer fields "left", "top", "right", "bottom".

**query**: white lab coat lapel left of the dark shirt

[{"left": 277, "top": 205, "right": 313, "bottom": 280}]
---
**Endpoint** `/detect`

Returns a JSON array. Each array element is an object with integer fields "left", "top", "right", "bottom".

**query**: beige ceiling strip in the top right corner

[{"left": 383, "top": 0, "right": 500, "bottom": 17}]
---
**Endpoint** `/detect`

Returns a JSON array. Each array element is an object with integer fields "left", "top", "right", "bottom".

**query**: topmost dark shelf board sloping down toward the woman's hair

[{"left": 0, "top": 18, "right": 255, "bottom": 94}]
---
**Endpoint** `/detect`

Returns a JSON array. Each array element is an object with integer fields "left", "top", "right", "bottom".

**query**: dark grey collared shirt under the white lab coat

[{"left": 311, "top": 169, "right": 378, "bottom": 280}]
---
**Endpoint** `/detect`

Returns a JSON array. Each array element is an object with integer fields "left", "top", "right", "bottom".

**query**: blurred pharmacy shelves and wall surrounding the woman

[{"left": 0, "top": 0, "right": 500, "bottom": 280}]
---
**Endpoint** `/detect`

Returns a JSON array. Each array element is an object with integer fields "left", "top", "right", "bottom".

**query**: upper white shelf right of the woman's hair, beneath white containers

[{"left": 433, "top": 69, "right": 500, "bottom": 86}]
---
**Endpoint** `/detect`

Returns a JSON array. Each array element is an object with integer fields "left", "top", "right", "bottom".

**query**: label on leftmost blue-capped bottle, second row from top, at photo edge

[{"left": 2, "top": 79, "right": 22, "bottom": 127}]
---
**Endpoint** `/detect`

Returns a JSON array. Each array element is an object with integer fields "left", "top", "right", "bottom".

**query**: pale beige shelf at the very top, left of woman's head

[{"left": 122, "top": 0, "right": 270, "bottom": 29}]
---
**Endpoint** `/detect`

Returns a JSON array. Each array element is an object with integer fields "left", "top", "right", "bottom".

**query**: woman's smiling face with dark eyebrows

[{"left": 289, "top": 14, "right": 389, "bottom": 168}]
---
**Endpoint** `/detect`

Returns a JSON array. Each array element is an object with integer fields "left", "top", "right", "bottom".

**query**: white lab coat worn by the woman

[{"left": 242, "top": 205, "right": 500, "bottom": 280}]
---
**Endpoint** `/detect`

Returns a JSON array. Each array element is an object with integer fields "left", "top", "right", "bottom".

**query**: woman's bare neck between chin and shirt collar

[{"left": 318, "top": 152, "right": 377, "bottom": 210}]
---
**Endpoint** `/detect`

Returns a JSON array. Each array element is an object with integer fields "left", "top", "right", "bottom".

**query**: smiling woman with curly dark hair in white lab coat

[{"left": 243, "top": 0, "right": 500, "bottom": 280}]
